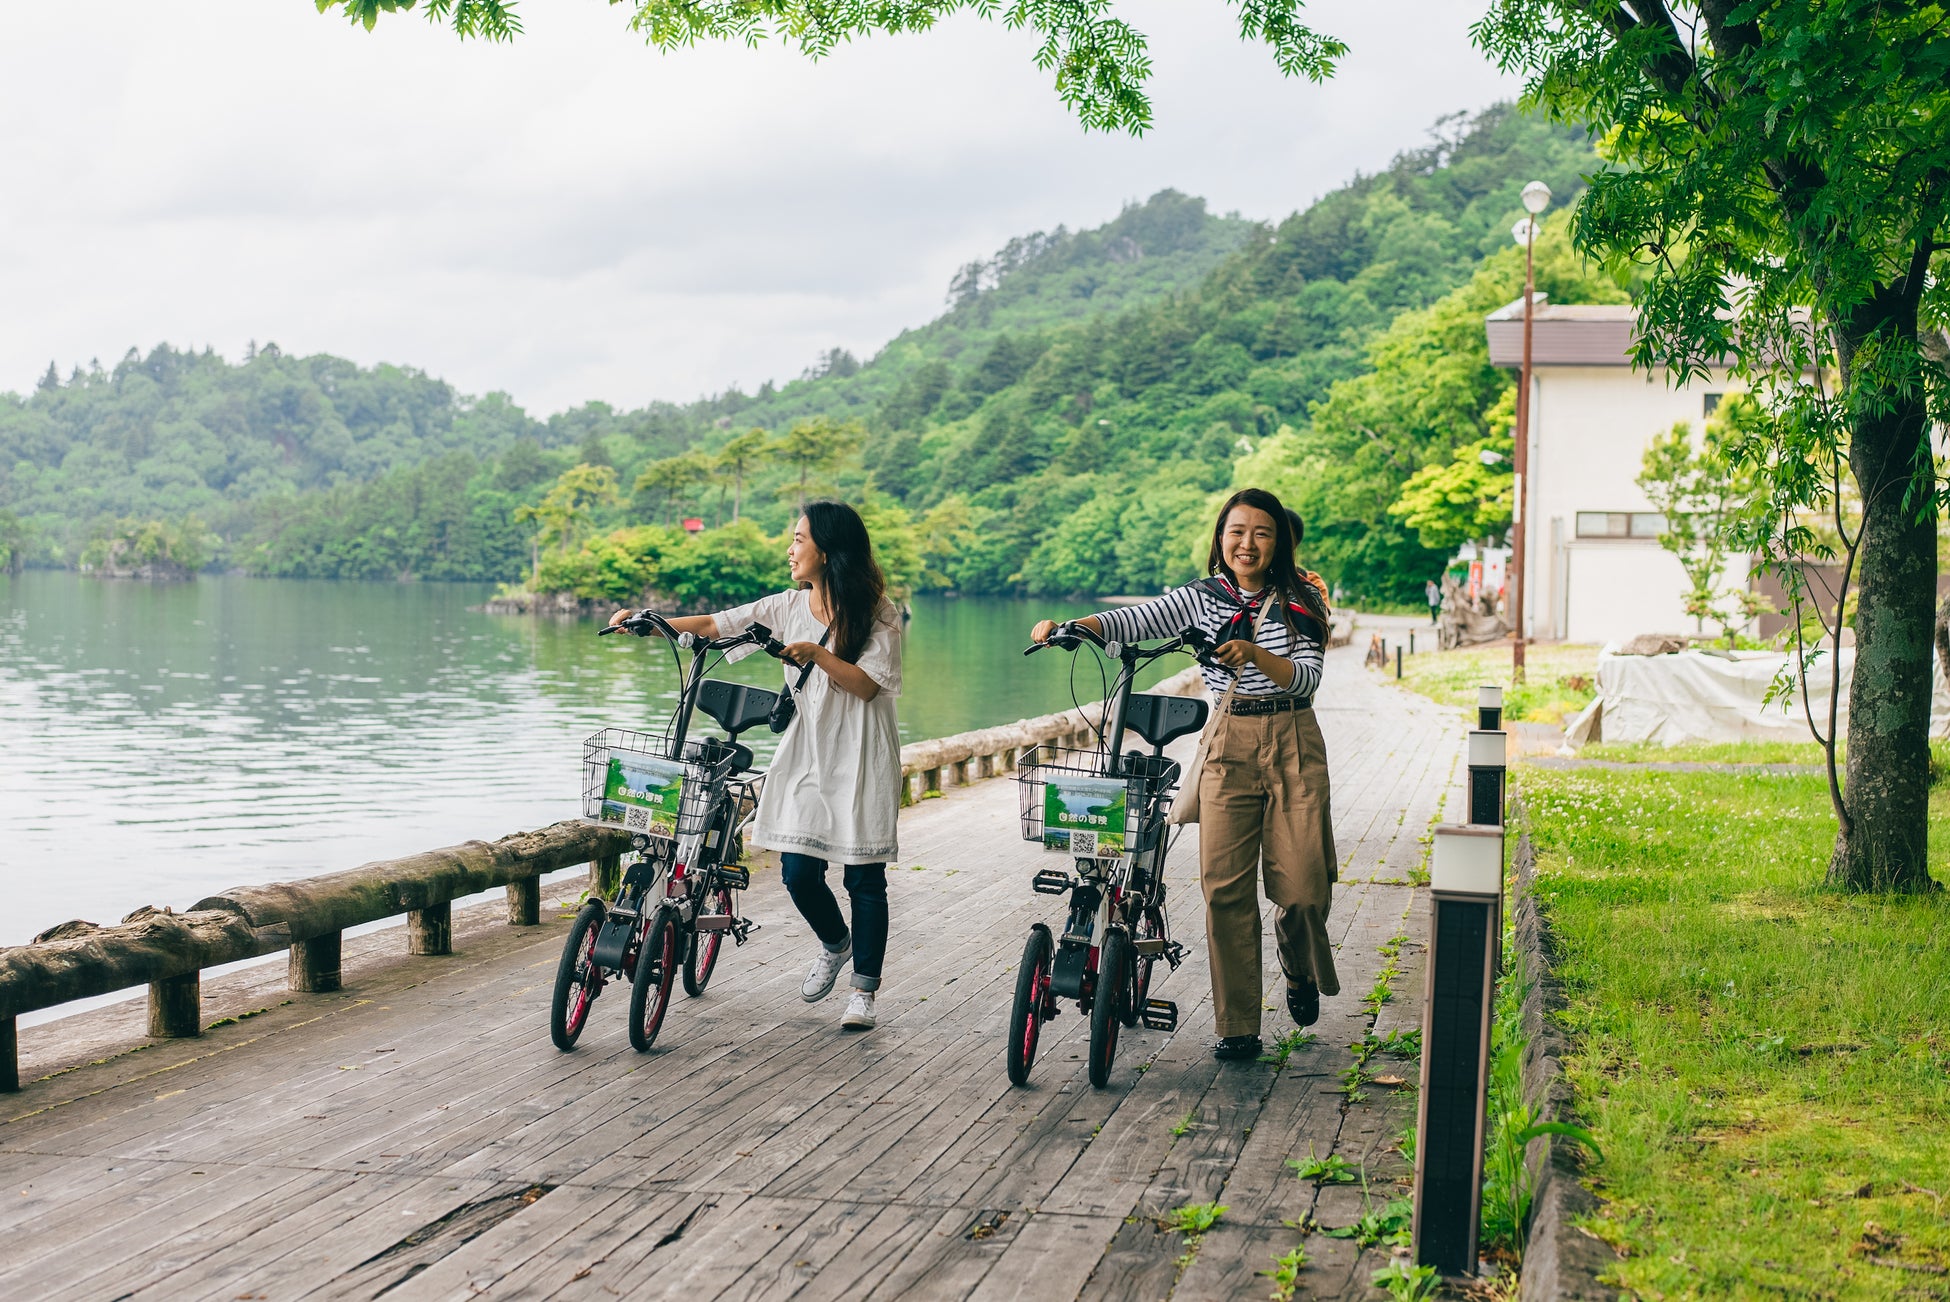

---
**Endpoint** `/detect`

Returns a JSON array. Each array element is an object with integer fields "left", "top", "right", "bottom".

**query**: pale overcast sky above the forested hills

[{"left": 0, "top": 0, "right": 1515, "bottom": 415}]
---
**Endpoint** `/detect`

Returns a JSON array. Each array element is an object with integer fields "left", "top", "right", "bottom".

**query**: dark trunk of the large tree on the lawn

[{"left": 1829, "top": 314, "right": 1936, "bottom": 891}]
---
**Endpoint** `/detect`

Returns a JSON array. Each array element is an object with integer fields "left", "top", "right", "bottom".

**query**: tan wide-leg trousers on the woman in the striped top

[{"left": 1199, "top": 709, "right": 1340, "bottom": 1035}]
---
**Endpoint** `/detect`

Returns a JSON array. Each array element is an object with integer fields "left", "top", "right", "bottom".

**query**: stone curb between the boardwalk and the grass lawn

[{"left": 1513, "top": 832, "right": 1630, "bottom": 1302}]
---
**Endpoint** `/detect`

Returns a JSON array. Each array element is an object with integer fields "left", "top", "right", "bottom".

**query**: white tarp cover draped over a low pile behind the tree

[{"left": 1566, "top": 647, "right": 1950, "bottom": 745}]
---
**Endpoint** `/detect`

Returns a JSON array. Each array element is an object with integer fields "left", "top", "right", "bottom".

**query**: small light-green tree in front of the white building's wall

[{"left": 1638, "top": 394, "right": 1759, "bottom": 649}]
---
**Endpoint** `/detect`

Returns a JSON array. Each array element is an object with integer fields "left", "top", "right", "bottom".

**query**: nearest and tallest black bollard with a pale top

[{"left": 1414, "top": 823, "right": 1503, "bottom": 1275}]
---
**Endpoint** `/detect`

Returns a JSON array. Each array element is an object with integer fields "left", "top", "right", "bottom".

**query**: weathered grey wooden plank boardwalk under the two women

[{"left": 0, "top": 649, "right": 1463, "bottom": 1302}]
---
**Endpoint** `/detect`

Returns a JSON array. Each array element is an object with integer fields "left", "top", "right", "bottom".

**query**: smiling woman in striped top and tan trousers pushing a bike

[{"left": 1032, "top": 489, "right": 1340, "bottom": 1058}]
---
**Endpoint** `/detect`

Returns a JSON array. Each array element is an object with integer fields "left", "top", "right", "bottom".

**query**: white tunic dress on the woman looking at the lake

[{"left": 716, "top": 589, "right": 903, "bottom": 863}]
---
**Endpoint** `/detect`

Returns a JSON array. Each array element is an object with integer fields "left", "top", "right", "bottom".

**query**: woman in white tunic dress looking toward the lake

[{"left": 610, "top": 501, "right": 903, "bottom": 1031}]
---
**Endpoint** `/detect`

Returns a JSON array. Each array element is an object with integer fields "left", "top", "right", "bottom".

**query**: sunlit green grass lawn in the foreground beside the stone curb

[{"left": 1513, "top": 766, "right": 1950, "bottom": 1298}]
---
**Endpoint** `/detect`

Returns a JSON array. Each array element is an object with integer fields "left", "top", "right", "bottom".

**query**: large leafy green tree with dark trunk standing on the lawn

[{"left": 1474, "top": 0, "right": 1950, "bottom": 891}]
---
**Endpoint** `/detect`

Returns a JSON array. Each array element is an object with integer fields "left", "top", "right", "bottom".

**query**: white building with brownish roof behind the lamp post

[{"left": 1486, "top": 298, "right": 1747, "bottom": 643}]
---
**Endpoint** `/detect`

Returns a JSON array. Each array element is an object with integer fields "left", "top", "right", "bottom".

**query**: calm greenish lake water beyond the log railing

[{"left": 0, "top": 571, "right": 1190, "bottom": 945}]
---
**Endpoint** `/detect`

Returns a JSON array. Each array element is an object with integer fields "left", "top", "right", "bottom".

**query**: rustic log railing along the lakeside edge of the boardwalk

[{"left": 0, "top": 670, "right": 1197, "bottom": 1091}]
